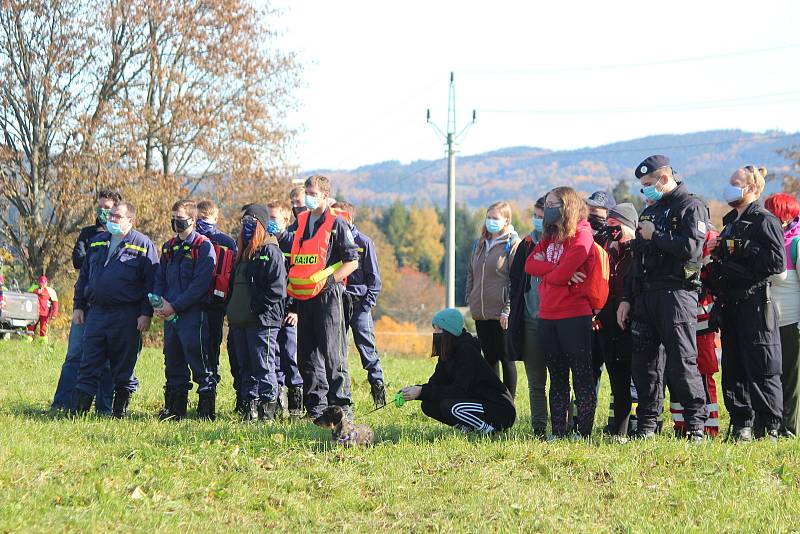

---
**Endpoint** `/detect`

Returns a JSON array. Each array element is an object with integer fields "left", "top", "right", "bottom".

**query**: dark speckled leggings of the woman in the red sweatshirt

[{"left": 539, "top": 315, "right": 597, "bottom": 437}]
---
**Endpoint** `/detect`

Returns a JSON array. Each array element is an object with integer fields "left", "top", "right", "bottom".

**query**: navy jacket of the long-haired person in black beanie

[{"left": 228, "top": 243, "right": 287, "bottom": 328}]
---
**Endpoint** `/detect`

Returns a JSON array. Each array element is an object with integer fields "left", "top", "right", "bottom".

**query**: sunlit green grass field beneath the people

[{"left": 0, "top": 341, "right": 800, "bottom": 533}]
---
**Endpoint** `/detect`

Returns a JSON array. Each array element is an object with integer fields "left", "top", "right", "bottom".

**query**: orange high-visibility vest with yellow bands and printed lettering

[{"left": 286, "top": 210, "right": 342, "bottom": 300}]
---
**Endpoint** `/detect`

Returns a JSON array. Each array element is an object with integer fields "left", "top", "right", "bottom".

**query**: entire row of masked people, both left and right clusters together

[{"left": 45, "top": 155, "right": 800, "bottom": 442}]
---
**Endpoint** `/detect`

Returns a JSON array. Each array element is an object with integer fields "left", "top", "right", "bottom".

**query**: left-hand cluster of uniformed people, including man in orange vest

[{"left": 51, "top": 176, "right": 386, "bottom": 421}]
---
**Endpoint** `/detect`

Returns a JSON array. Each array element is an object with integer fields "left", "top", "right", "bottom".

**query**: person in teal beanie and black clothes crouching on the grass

[{"left": 400, "top": 308, "right": 517, "bottom": 434}]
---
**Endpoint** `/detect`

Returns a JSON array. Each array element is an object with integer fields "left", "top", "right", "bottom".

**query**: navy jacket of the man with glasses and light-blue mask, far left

[{"left": 73, "top": 230, "right": 158, "bottom": 316}]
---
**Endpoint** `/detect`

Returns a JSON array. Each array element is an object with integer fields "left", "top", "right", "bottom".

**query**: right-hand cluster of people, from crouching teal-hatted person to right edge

[{"left": 402, "top": 155, "right": 800, "bottom": 442}]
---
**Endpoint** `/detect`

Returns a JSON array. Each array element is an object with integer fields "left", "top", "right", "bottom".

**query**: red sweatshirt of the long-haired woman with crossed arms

[{"left": 525, "top": 221, "right": 595, "bottom": 319}]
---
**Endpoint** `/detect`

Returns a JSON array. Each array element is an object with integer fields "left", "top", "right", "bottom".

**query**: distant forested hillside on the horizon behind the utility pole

[{"left": 314, "top": 130, "right": 800, "bottom": 207}]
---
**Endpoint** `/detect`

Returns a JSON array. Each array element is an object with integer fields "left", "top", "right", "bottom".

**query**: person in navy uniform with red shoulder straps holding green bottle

[{"left": 153, "top": 200, "right": 216, "bottom": 419}]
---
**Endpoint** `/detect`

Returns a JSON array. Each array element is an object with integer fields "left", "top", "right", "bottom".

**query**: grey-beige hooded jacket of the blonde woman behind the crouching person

[{"left": 466, "top": 228, "right": 520, "bottom": 321}]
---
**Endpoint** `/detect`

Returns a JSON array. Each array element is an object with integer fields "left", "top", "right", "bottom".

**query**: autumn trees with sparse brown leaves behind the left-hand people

[{"left": 0, "top": 0, "right": 299, "bottom": 282}]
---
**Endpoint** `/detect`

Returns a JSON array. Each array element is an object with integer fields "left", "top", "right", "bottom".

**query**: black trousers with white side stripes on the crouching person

[{"left": 422, "top": 399, "right": 517, "bottom": 434}]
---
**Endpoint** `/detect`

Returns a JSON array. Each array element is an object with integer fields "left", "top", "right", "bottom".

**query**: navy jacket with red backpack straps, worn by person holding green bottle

[{"left": 153, "top": 230, "right": 217, "bottom": 314}]
